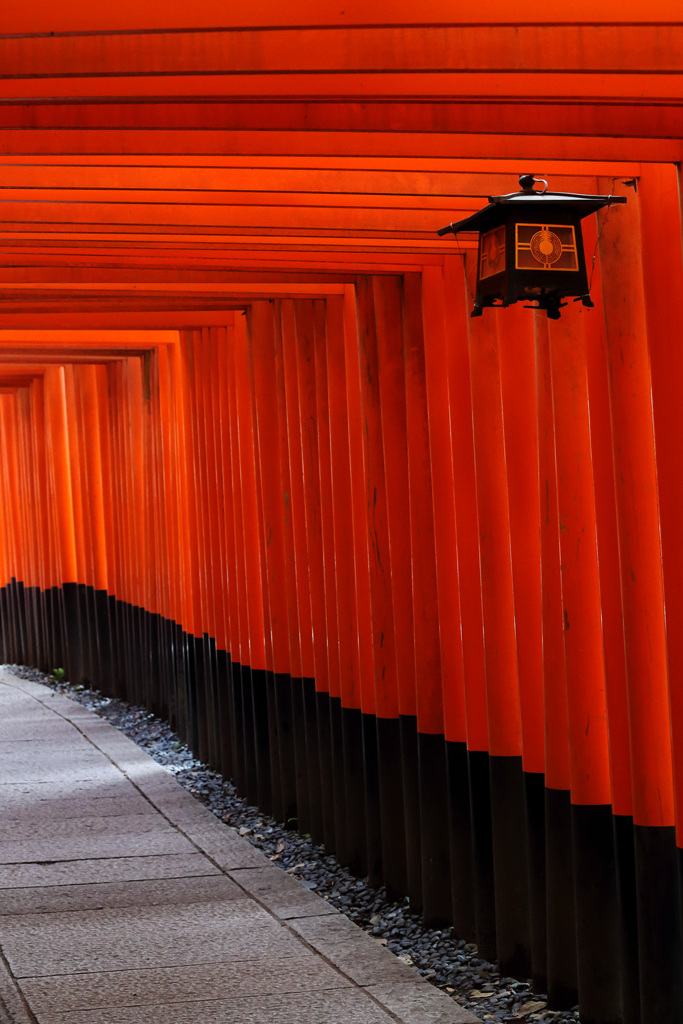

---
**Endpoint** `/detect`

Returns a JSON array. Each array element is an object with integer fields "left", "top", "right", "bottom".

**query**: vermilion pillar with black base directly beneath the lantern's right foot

[{"left": 548, "top": 313, "right": 622, "bottom": 1022}]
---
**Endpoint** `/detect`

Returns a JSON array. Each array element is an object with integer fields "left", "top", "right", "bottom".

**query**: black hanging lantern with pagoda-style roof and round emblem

[{"left": 437, "top": 174, "right": 626, "bottom": 319}]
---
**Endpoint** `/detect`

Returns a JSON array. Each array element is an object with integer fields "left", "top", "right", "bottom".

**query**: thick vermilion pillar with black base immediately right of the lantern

[{"left": 600, "top": 175, "right": 683, "bottom": 1022}]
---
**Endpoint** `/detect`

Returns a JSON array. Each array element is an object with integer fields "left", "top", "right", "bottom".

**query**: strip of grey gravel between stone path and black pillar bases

[{"left": 2, "top": 665, "right": 579, "bottom": 1024}]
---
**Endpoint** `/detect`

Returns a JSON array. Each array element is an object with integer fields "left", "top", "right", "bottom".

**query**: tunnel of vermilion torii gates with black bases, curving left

[{"left": 0, "top": 6, "right": 683, "bottom": 1024}]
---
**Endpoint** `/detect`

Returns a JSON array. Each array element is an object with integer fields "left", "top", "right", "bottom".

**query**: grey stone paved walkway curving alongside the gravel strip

[{"left": 0, "top": 670, "right": 478, "bottom": 1024}]
